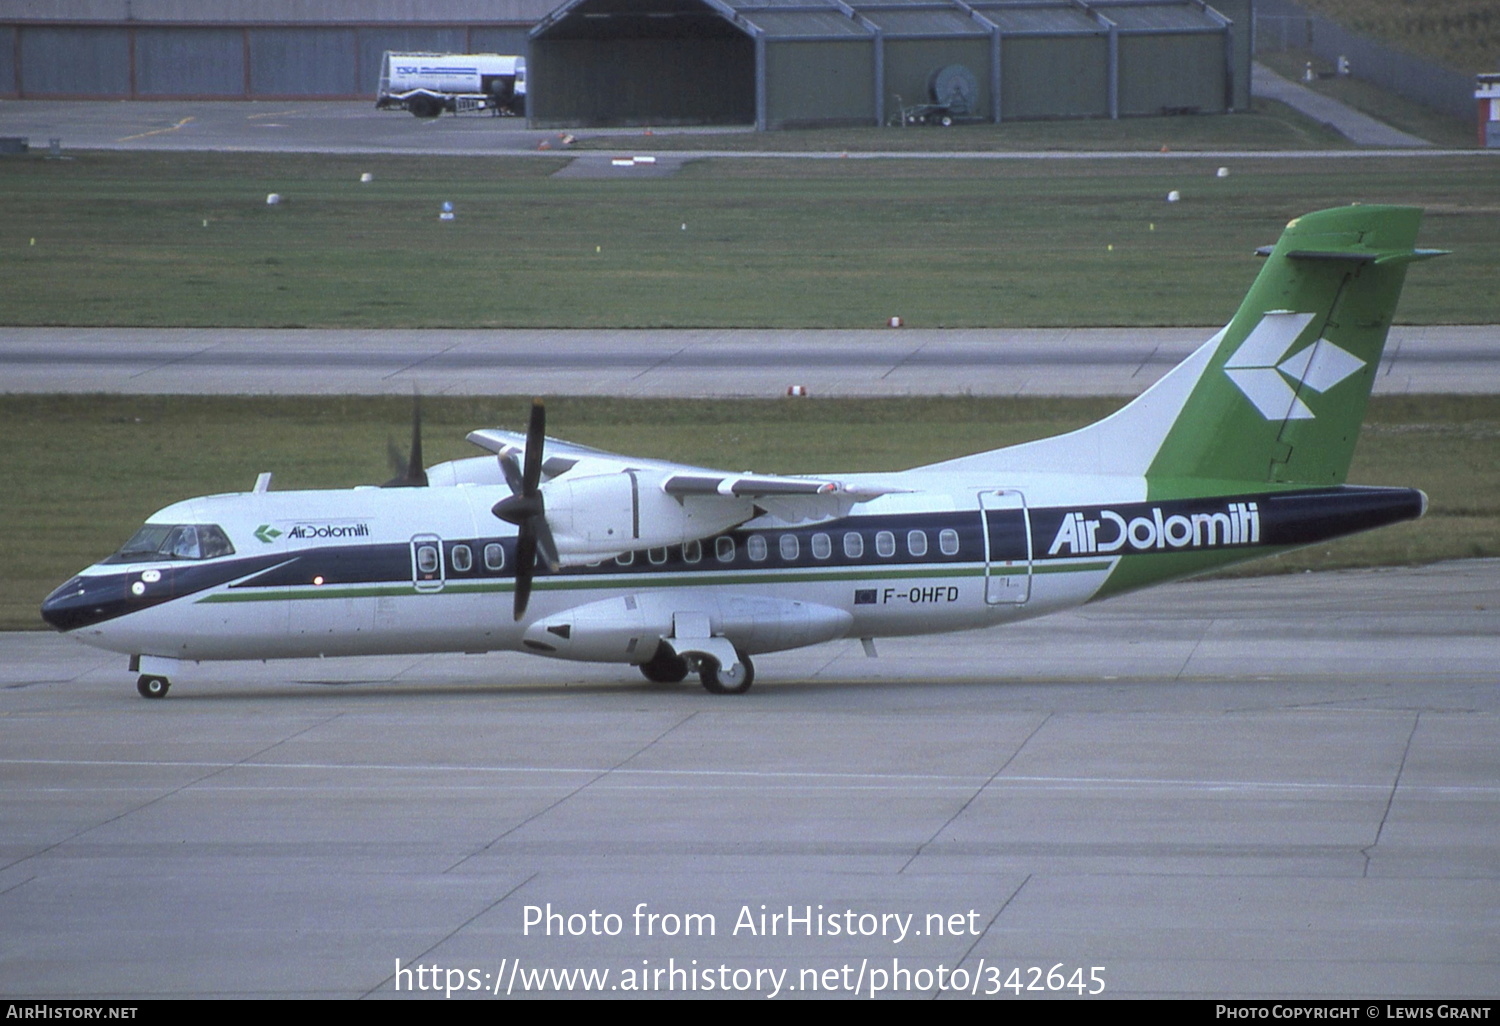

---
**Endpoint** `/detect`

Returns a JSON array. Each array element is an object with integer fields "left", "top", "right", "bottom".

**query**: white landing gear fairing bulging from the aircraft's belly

[{"left": 522, "top": 590, "right": 854, "bottom": 663}]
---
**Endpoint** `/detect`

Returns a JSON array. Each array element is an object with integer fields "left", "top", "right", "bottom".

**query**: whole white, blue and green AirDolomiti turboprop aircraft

[{"left": 42, "top": 206, "right": 1439, "bottom": 698}]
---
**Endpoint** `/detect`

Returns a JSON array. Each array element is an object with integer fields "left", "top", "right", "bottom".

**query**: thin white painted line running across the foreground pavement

[{"left": 0, "top": 759, "right": 1500, "bottom": 797}]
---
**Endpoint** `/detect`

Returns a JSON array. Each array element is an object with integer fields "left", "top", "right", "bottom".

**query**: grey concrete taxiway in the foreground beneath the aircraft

[{"left": 0, "top": 561, "right": 1500, "bottom": 999}]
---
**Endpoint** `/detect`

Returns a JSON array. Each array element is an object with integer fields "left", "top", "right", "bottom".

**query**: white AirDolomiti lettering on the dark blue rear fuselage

[{"left": 1047, "top": 503, "right": 1260, "bottom": 557}]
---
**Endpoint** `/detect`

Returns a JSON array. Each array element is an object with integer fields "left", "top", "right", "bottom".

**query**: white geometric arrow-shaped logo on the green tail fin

[{"left": 1224, "top": 311, "right": 1365, "bottom": 420}]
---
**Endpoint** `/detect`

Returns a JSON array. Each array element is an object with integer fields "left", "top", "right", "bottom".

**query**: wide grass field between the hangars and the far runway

[{"left": 0, "top": 148, "right": 1500, "bottom": 329}]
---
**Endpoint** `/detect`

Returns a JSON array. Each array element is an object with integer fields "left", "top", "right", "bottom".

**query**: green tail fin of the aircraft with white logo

[{"left": 1146, "top": 207, "right": 1439, "bottom": 495}]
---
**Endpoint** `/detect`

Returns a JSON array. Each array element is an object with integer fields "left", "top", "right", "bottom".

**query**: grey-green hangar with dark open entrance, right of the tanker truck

[{"left": 528, "top": 0, "right": 1251, "bottom": 129}]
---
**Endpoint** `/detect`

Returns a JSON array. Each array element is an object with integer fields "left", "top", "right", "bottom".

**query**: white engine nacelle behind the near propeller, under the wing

[{"left": 542, "top": 471, "right": 755, "bottom": 566}]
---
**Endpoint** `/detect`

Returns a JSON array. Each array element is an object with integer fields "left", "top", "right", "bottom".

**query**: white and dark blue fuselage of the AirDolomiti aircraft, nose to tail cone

[{"left": 42, "top": 471, "right": 1424, "bottom": 662}]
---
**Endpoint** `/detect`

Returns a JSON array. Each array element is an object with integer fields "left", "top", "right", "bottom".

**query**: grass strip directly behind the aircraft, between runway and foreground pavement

[{"left": 0, "top": 396, "right": 1500, "bottom": 630}]
